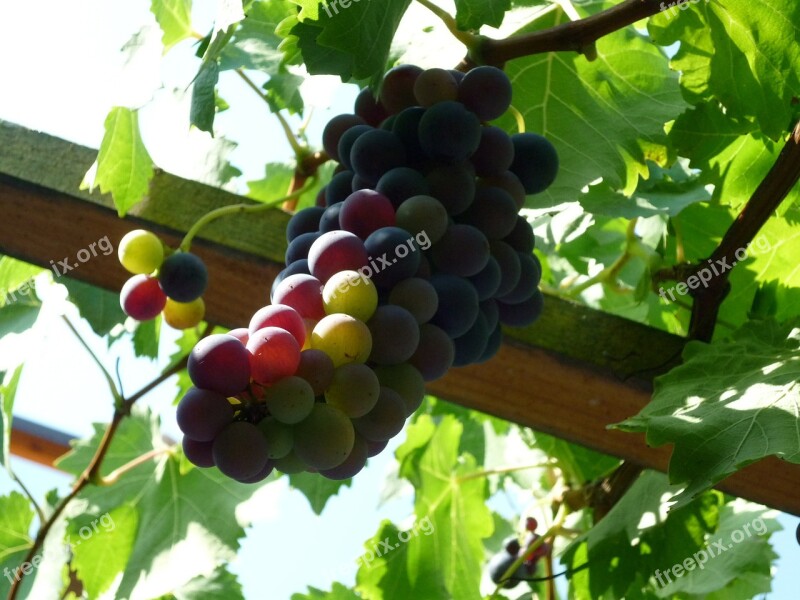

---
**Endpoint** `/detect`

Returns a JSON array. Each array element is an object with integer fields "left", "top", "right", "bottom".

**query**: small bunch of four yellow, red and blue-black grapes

[{"left": 118, "top": 229, "right": 208, "bottom": 329}]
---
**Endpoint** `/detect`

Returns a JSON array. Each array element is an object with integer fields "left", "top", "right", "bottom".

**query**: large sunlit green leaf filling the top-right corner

[{"left": 650, "top": 0, "right": 800, "bottom": 139}]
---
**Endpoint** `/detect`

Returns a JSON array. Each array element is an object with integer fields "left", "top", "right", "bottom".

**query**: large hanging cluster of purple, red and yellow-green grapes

[{"left": 178, "top": 65, "right": 558, "bottom": 482}]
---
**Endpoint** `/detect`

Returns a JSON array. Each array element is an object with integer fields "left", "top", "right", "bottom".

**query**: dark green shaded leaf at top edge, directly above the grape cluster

[{"left": 292, "top": 0, "right": 411, "bottom": 81}]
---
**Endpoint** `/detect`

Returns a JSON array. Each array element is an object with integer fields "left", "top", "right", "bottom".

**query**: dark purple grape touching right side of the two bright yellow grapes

[{"left": 367, "top": 304, "right": 419, "bottom": 365}]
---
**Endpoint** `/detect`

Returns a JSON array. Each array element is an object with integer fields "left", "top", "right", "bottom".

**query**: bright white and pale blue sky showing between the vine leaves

[{"left": 0, "top": 0, "right": 800, "bottom": 600}]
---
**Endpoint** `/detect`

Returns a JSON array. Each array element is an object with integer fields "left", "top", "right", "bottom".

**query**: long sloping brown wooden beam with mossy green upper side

[{"left": 0, "top": 123, "right": 800, "bottom": 514}]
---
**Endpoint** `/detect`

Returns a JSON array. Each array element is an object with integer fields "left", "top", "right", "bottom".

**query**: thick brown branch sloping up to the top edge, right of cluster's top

[{"left": 474, "top": 0, "right": 664, "bottom": 66}]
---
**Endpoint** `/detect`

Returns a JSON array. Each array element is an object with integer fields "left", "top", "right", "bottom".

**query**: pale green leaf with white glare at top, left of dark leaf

[{"left": 220, "top": 0, "right": 293, "bottom": 75}]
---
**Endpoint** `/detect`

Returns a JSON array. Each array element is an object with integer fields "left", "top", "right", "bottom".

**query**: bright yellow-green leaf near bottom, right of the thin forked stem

[{"left": 66, "top": 504, "right": 139, "bottom": 598}]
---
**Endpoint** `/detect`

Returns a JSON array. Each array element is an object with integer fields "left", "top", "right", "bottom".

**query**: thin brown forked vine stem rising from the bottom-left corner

[{"left": 8, "top": 324, "right": 214, "bottom": 600}]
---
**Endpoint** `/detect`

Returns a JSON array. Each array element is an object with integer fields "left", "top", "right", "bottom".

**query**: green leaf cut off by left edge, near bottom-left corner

[{"left": 0, "top": 492, "right": 35, "bottom": 595}]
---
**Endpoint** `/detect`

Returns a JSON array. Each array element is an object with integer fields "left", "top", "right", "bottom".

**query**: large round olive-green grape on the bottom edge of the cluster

[{"left": 294, "top": 402, "right": 355, "bottom": 470}]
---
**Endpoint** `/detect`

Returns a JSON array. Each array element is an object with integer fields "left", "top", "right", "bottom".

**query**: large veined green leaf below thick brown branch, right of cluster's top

[{"left": 500, "top": 5, "right": 686, "bottom": 207}]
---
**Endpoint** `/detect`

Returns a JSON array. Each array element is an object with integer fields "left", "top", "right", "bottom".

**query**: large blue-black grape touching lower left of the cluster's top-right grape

[{"left": 419, "top": 100, "right": 481, "bottom": 163}]
